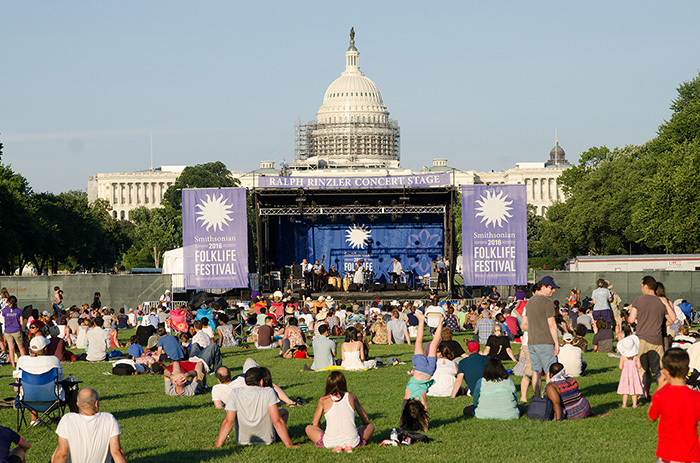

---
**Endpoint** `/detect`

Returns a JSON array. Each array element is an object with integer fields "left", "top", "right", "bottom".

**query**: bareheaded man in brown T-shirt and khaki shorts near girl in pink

[{"left": 627, "top": 275, "right": 676, "bottom": 399}]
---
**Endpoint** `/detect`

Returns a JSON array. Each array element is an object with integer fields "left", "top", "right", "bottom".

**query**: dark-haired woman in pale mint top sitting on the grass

[{"left": 463, "top": 358, "right": 522, "bottom": 420}]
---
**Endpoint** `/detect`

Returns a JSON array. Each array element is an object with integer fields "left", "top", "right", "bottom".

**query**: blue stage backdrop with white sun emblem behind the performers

[{"left": 276, "top": 217, "right": 443, "bottom": 282}]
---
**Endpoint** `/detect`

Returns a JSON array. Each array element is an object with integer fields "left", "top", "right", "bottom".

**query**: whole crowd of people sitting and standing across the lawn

[{"left": 0, "top": 276, "right": 700, "bottom": 461}]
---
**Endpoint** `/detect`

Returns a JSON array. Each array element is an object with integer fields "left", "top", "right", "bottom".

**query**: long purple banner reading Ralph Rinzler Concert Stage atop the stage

[{"left": 257, "top": 172, "right": 452, "bottom": 190}]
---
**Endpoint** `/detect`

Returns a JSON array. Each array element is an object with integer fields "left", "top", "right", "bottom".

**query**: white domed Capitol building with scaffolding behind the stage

[{"left": 88, "top": 30, "right": 571, "bottom": 219}]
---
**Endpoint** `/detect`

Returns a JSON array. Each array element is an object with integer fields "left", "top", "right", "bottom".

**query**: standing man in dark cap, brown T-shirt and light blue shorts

[{"left": 523, "top": 275, "right": 559, "bottom": 396}]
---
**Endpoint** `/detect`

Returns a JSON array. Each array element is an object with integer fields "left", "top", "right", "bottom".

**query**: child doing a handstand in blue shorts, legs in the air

[{"left": 399, "top": 314, "right": 443, "bottom": 431}]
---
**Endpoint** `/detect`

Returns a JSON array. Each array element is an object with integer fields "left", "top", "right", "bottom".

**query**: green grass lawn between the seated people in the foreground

[{"left": 0, "top": 330, "right": 656, "bottom": 463}]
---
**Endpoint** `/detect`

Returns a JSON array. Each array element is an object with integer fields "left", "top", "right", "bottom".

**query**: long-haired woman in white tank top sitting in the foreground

[{"left": 306, "top": 371, "right": 374, "bottom": 453}]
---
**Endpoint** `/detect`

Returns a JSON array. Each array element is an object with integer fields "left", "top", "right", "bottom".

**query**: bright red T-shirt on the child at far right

[{"left": 649, "top": 384, "right": 700, "bottom": 461}]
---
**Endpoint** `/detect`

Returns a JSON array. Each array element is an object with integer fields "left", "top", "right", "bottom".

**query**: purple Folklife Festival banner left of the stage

[{"left": 182, "top": 188, "right": 248, "bottom": 289}]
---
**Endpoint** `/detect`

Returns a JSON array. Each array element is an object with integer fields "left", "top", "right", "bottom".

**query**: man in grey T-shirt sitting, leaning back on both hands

[{"left": 214, "top": 368, "right": 298, "bottom": 448}]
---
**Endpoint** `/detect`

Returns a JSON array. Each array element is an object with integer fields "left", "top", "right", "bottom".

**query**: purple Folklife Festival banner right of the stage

[{"left": 462, "top": 185, "right": 527, "bottom": 286}]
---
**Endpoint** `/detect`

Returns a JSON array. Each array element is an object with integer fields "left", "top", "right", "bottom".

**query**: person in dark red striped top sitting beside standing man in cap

[{"left": 544, "top": 362, "right": 593, "bottom": 421}]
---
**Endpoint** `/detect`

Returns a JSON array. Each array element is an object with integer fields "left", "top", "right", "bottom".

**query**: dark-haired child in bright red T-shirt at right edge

[{"left": 649, "top": 347, "right": 700, "bottom": 461}]
